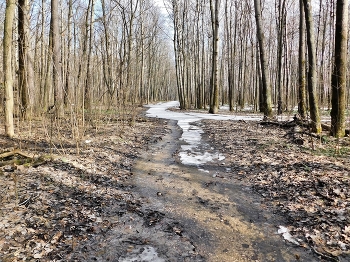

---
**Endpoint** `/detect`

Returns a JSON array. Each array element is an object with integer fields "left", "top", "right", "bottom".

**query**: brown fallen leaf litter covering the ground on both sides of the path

[{"left": 0, "top": 105, "right": 350, "bottom": 261}]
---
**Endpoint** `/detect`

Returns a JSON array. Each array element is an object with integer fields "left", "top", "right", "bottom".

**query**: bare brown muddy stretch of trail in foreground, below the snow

[{"left": 76, "top": 120, "right": 319, "bottom": 262}]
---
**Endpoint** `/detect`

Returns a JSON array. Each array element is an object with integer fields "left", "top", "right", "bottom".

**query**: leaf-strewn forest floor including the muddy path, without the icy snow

[{"left": 0, "top": 105, "right": 350, "bottom": 262}]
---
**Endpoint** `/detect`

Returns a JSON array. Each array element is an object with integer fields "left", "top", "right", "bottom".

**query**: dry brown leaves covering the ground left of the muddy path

[{"left": 0, "top": 111, "right": 164, "bottom": 262}]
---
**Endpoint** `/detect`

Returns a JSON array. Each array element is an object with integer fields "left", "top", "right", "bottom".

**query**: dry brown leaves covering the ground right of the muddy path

[{"left": 204, "top": 121, "right": 350, "bottom": 261}]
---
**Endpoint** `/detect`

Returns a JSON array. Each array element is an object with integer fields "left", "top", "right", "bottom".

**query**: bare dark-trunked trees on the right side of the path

[{"left": 166, "top": 0, "right": 350, "bottom": 137}]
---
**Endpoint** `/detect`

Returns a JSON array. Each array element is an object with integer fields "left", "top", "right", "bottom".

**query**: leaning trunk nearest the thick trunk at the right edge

[{"left": 303, "top": 0, "right": 322, "bottom": 133}]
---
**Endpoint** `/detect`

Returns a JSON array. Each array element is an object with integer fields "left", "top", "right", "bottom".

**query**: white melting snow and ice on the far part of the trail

[{"left": 147, "top": 101, "right": 261, "bottom": 166}]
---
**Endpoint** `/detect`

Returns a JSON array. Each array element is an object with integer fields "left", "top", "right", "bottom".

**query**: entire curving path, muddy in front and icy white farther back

[{"left": 118, "top": 102, "right": 318, "bottom": 262}]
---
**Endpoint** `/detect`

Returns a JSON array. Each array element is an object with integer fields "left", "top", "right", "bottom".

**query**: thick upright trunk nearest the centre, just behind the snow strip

[{"left": 209, "top": 0, "right": 220, "bottom": 114}]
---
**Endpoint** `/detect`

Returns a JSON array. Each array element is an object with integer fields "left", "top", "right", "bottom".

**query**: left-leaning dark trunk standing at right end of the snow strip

[{"left": 254, "top": 0, "right": 272, "bottom": 117}]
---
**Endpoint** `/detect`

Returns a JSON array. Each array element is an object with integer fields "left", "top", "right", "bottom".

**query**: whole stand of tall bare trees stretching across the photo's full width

[{"left": 0, "top": 0, "right": 349, "bottom": 137}]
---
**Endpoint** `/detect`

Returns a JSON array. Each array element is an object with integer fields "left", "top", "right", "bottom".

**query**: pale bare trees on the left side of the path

[{"left": 0, "top": 0, "right": 177, "bottom": 136}]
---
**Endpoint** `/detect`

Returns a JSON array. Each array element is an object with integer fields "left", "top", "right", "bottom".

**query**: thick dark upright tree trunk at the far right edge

[{"left": 331, "top": 0, "right": 348, "bottom": 137}]
